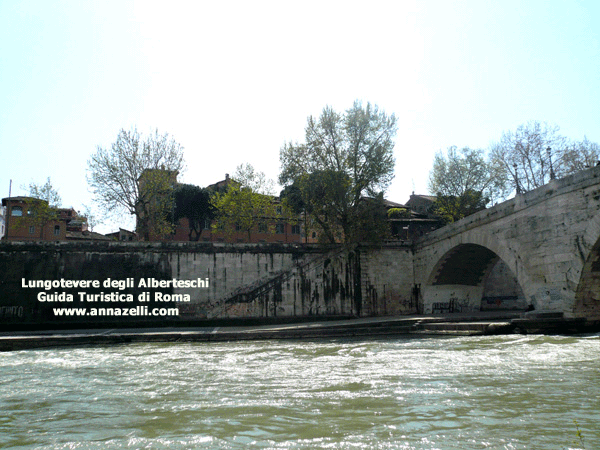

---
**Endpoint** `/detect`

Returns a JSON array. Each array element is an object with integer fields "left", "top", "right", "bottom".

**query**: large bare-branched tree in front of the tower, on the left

[{"left": 88, "top": 128, "right": 185, "bottom": 240}]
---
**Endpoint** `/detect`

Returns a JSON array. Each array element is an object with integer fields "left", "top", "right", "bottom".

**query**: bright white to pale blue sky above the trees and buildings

[{"left": 0, "top": 0, "right": 600, "bottom": 232}]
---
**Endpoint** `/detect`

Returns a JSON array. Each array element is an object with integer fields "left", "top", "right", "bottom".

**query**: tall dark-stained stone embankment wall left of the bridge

[{"left": 0, "top": 242, "right": 417, "bottom": 327}]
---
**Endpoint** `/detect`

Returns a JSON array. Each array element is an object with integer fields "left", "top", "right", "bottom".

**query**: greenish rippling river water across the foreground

[{"left": 0, "top": 335, "right": 600, "bottom": 450}]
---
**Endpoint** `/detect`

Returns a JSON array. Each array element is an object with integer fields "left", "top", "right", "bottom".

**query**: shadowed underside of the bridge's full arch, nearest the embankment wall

[{"left": 423, "top": 244, "right": 527, "bottom": 314}]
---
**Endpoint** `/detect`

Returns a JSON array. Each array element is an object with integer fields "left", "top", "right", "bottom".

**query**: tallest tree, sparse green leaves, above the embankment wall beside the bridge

[{"left": 279, "top": 101, "right": 397, "bottom": 243}]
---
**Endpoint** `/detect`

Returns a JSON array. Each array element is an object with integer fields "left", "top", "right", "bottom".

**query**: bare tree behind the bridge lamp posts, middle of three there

[{"left": 492, "top": 122, "right": 566, "bottom": 192}]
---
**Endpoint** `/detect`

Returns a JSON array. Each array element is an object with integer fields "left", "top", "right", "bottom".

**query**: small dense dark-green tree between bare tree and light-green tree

[{"left": 173, "top": 184, "right": 214, "bottom": 241}]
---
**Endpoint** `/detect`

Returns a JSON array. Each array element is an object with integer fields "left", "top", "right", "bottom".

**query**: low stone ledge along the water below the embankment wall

[{"left": 0, "top": 313, "right": 600, "bottom": 351}]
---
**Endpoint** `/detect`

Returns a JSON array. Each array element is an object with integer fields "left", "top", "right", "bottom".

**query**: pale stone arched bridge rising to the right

[{"left": 413, "top": 163, "right": 600, "bottom": 320}]
